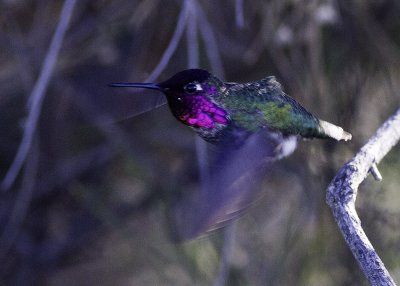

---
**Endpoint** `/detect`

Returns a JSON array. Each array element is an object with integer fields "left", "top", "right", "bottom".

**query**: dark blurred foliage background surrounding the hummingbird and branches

[{"left": 0, "top": 0, "right": 400, "bottom": 286}]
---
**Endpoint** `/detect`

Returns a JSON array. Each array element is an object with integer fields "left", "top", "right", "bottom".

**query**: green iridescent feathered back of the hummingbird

[{"left": 220, "top": 76, "right": 320, "bottom": 137}]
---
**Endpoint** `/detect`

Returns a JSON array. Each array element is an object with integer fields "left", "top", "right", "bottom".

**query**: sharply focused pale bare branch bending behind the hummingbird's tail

[{"left": 326, "top": 109, "right": 400, "bottom": 285}]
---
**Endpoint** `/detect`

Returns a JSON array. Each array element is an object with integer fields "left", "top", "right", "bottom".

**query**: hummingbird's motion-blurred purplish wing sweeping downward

[{"left": 170, "top": 131, "right": 297, "bottom": 240}]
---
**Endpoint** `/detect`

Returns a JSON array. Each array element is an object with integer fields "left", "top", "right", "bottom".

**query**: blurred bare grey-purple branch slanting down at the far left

[{"left": 1, "top": 0, "right": 76, "bottom": 191}]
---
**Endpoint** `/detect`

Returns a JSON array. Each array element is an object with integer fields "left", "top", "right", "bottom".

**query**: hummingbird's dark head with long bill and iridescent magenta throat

[{"left": 111, "top": 69, "right": 230, "bottom": 141}]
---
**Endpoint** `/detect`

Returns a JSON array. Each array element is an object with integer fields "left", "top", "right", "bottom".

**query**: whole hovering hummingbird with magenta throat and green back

[{"left": 110, "top": 69, "right": 352, "bottom": 239}]
